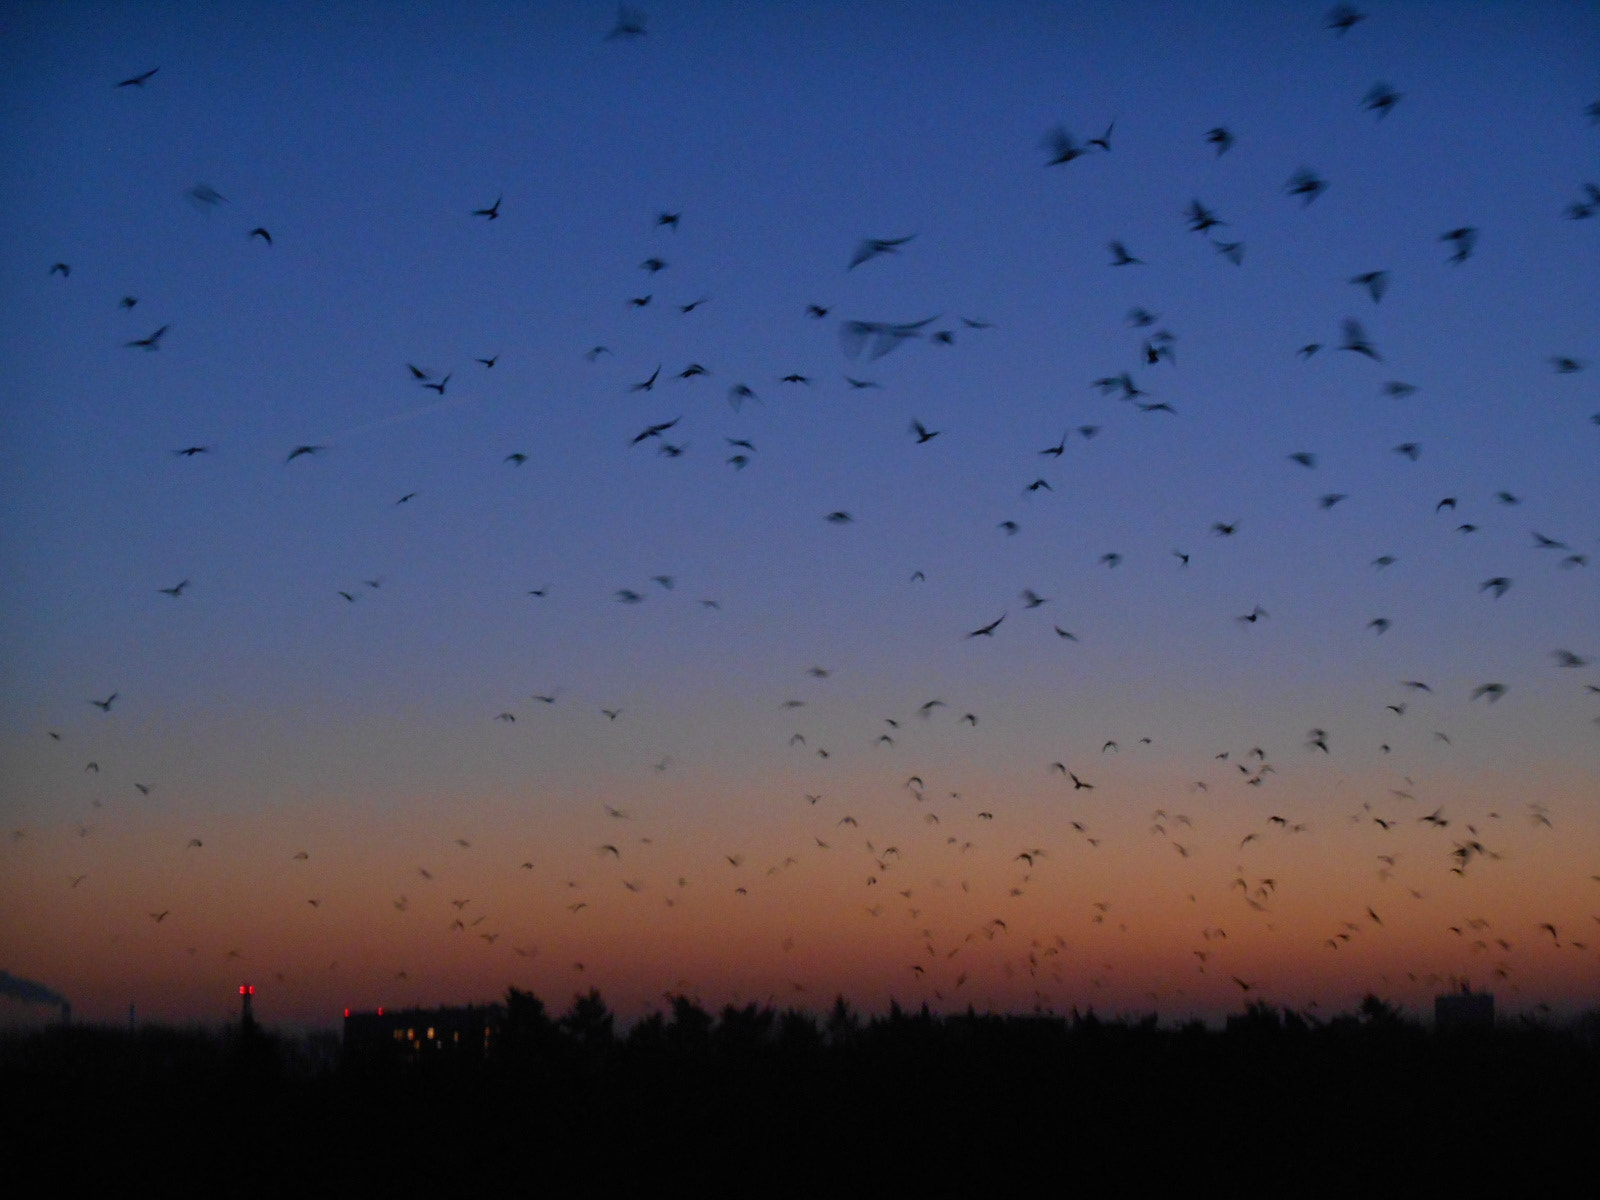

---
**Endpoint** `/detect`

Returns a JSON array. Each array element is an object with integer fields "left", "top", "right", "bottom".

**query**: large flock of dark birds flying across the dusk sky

[{"left": 11, "top": 5, "right": 1600, "bottom": 1030}]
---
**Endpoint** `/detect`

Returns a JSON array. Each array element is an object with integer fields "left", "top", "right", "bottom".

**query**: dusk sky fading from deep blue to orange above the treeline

[{"left": 0, "top": 2, "right": 1600, "bottom": 1027}]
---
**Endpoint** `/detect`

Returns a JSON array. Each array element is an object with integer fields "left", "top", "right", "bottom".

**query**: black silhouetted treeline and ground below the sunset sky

[{"left": 0, "top": 992, "right": 1600, "bottom": 1197}]
